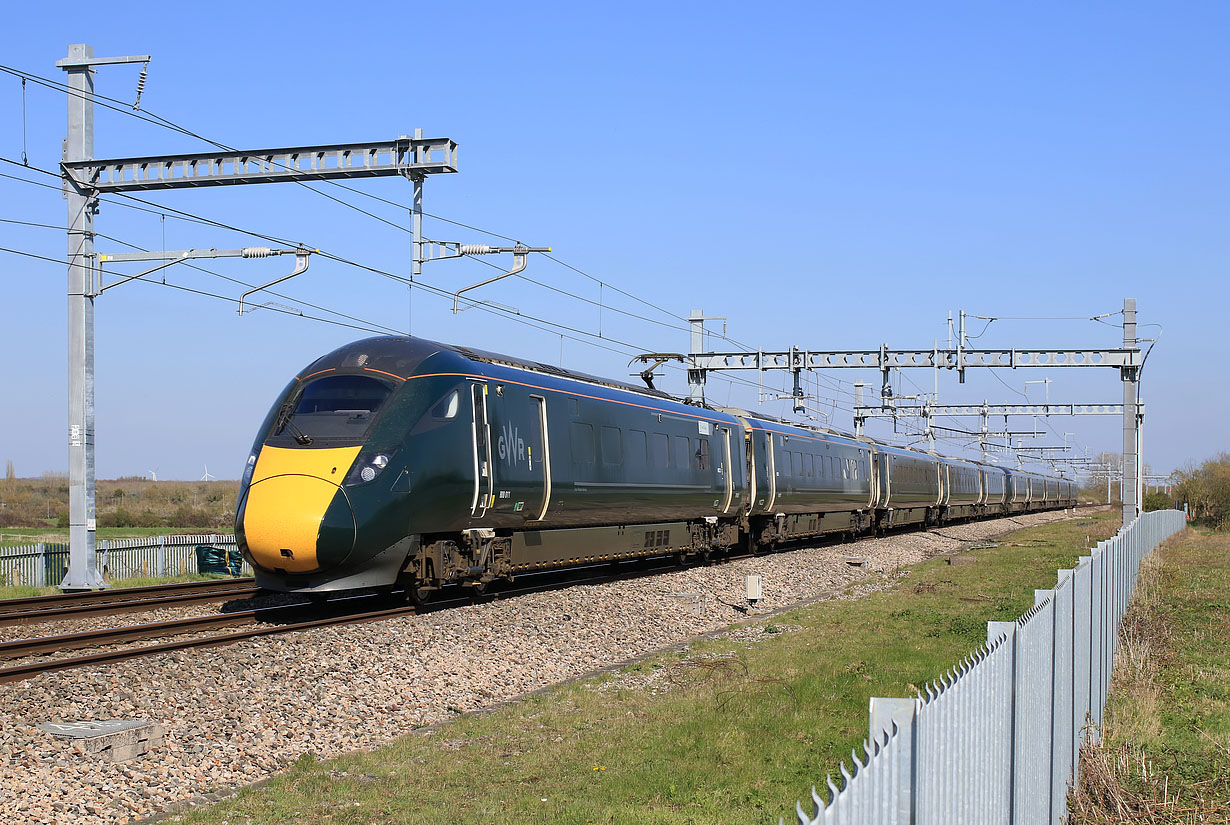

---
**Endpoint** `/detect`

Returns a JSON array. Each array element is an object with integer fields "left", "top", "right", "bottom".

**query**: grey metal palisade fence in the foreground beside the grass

[{"left": 797, "top": 510, "right": 1186, "bottom": 825}]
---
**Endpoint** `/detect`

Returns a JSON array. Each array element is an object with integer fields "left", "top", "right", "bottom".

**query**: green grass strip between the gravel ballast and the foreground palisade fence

[{"left": 175, "top": 514, "right": 1118, "bottom": 825}]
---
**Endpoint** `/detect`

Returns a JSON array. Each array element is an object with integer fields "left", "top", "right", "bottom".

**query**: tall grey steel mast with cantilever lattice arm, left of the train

[{"left": 55, "top": 43, "right": 458, "bottom": 590}]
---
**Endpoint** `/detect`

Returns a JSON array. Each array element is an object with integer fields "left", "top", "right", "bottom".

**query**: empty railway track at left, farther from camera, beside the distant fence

[{"left": 0, "top": 578, "right": 262, "bottom": 625}]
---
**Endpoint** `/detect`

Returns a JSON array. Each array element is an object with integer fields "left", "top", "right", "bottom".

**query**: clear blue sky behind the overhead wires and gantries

[{"left": 0, "top": 2, "right": 1230, "bottom": 478}]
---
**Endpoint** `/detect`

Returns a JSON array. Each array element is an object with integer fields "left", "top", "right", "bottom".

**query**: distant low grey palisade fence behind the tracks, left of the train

[{"left": 0, "top": 535, "right": 252, "bottom": 586}]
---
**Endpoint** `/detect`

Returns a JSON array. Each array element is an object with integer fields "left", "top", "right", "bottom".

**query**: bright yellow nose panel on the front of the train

[{"left": 244, "top": 446, "right": 359, "bottom": 573}]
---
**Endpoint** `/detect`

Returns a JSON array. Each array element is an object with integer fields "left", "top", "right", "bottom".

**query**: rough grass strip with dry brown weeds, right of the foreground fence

[{"left": 1069, "top": 530, "right": 1230, "bottom": 825}]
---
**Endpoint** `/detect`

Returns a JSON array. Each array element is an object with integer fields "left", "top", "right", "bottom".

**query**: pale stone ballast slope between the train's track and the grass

[{"left": 0, "top": 513, "right": 1087, "bottom": 825}]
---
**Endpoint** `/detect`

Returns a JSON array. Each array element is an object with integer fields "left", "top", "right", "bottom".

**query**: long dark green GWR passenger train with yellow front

[{"left": 235, "top": 336, "right": 1076, "bottom": 600}]
